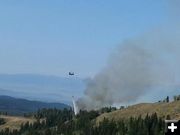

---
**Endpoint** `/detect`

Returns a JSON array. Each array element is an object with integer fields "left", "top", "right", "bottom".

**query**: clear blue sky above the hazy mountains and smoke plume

[{"left": 0, "top": 0, "right": 167, "bottom": 78}]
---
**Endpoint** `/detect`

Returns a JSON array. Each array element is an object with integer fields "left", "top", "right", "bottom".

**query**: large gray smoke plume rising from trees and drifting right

[{"left": 77, "top": 0, "right": 180, "bottom": 110}]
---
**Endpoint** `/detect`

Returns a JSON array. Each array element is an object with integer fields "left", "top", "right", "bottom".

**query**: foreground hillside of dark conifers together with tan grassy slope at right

[{"left": 0, "top": 96, "right": 180, "bottom": 135}]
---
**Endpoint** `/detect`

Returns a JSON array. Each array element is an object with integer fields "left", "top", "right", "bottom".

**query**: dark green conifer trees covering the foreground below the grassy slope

[{"left": 0, "top": 109, "right": 165, "bottom": 135}]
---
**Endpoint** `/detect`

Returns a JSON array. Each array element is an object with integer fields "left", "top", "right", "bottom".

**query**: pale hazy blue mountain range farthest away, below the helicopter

[{"left": 0, "top": 74, "right": 85, "bottom": 104}]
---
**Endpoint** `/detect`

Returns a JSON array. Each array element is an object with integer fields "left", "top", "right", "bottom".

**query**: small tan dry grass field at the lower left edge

[{"left": 0, "top": 115, "right": 35, "bottom": 130}]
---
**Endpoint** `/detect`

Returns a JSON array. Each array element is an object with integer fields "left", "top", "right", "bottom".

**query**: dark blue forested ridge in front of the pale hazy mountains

[{"left": 0, "top": 95, "right": 70, "bottom": 115}]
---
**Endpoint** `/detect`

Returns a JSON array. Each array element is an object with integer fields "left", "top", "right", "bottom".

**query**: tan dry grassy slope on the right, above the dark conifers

[{"left": 97, "top": 101, "right": 180, "bottom": 122}]
